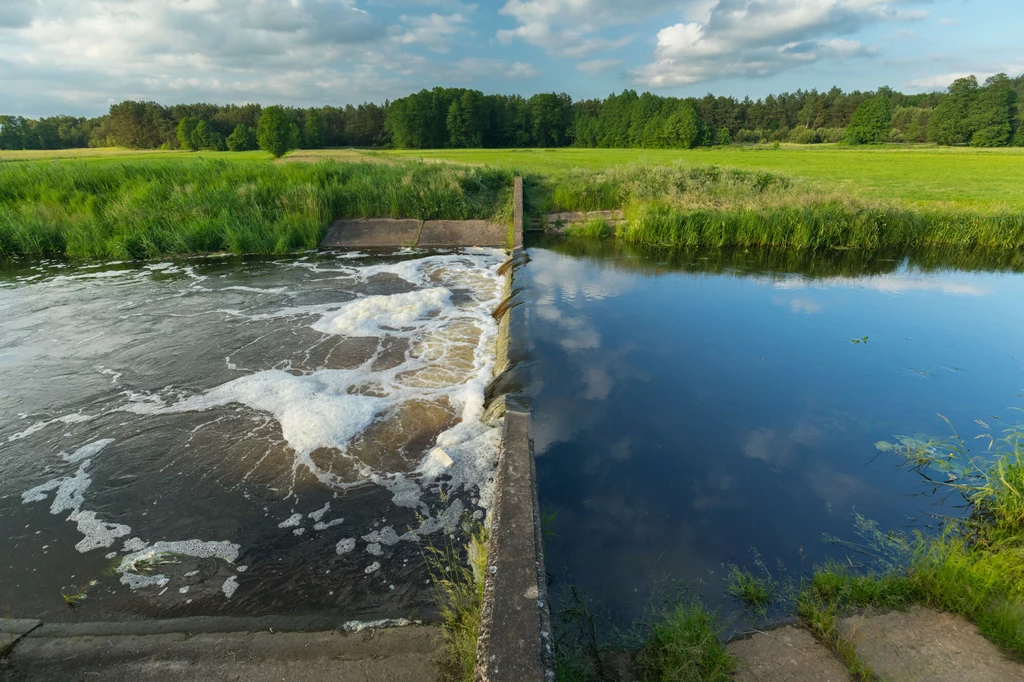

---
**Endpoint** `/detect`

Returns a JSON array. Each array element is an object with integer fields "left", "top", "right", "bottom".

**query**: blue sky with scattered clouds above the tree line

[{"left": 0, "top": 0, "right": 1024, "bottom": 117}]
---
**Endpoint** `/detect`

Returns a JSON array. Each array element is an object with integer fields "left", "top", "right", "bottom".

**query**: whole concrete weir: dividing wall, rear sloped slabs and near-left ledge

[{"left": 0, "top": 177, "right": 555, "bottom": 682}]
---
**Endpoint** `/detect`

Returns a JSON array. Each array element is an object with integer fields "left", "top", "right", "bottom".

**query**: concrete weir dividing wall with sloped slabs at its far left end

[{"left": 322, "top": 176, "right": 555, "bottom": 682}]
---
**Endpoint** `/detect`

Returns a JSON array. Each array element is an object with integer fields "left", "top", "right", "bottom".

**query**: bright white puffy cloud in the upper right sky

[{"left": 633, "top": 0, "right": 925, "bottom": 87}]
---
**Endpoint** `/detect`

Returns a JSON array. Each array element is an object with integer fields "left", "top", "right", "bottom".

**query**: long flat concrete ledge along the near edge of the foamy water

[{"left": 0, "top": 626, "right": 442, "bottom": 682}]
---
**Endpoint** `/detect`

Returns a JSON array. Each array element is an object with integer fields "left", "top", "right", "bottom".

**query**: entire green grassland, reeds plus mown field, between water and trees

[{"left": 0, "top": 145, "right": 1024, "bottom": 258}]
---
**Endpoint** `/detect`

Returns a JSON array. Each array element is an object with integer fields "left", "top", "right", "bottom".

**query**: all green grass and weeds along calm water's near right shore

[{"left": 554, "top": 417, "right": 1024, "bottom": 682}]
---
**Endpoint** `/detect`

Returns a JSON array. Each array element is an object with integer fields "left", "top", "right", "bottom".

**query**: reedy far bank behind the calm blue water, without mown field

[{"left": 525, "top": 164, "right": 1024, "bottom": 250}]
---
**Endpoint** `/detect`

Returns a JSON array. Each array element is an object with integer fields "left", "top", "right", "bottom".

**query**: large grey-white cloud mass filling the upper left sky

[{"left": 0, "top": 0, "right": 537, "bottom": 115}]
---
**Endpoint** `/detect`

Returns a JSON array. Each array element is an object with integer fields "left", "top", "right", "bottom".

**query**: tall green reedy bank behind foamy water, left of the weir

[{"left": 0, "top": 158, "right": 511, "bottom": 259}]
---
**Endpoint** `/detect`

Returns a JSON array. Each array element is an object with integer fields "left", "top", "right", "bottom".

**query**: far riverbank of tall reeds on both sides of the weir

[{"left": 0, "top": 153, "right": 1024, "bottom": 259}]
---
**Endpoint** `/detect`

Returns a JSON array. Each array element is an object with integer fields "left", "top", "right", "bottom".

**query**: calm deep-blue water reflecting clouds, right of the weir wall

[{"left": 517, "top": 241, "right": 1024, "bottom": 625}]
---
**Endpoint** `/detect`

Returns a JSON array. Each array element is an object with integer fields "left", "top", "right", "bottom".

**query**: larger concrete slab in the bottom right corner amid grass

[{"left": 839, "top": 606, "right": 1024, "bottom": 682}]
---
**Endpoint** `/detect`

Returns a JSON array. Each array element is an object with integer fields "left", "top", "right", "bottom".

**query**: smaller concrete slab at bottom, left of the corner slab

[{"left": 726, "top": 626, "right": 852, "bottom": 682}]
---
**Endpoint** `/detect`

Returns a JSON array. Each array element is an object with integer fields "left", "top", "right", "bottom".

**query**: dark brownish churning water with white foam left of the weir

[{"left": 0, "top": 251, "right": 502, "bottom": 620}]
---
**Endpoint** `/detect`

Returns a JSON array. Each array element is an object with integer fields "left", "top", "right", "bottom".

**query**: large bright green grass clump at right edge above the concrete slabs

[{"left": 797, "top": 419, "right": 1024, "bottom": 659}]
